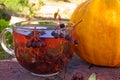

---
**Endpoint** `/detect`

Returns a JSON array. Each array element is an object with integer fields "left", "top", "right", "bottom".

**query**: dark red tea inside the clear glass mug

[{"left": 13, "top": 27, "right": 73, "bottom": 75}]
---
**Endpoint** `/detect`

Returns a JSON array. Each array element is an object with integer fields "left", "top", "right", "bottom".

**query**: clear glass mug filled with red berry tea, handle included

[{"left": 0, "top": 20, "right": 74, "bottom": 76}]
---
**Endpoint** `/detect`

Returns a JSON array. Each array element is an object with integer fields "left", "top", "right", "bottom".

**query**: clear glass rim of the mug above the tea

[{"left": 12, "top": 19, "right": 75, "bottom": 27}]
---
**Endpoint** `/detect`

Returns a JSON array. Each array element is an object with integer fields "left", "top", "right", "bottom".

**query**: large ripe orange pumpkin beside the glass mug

[{"left": 70, "top": 0, "right": 120, "bottom": 67}]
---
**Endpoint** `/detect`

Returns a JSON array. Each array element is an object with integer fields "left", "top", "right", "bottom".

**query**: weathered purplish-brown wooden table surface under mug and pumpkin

[{"left": 0, "top": 55, "right": 120, "bottom": 80}]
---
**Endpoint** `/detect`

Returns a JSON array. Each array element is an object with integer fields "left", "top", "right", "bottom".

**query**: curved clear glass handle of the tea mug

[{"left": 0, "top": 28, "right": 15, "bottom": 57}]
